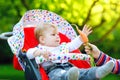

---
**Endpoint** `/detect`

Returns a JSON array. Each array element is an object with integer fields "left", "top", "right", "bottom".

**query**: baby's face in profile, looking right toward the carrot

[{"left": 44, "top": 27, "right": 60, "bottom": 47}]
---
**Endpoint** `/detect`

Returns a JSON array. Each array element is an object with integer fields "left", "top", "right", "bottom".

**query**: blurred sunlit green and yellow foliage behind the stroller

[{"left": 0, "top": 0, "right": 120, "bottom": 63}]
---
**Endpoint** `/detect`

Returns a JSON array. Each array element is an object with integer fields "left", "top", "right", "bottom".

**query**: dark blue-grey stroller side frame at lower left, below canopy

[{"left": 18, "top": 50, "right": 42, "bottom": 80}]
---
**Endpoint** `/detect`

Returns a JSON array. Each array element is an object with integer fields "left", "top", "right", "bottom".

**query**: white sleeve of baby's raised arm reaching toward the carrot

[{"left": 67, "top": 36, "right": 83, "bottom": 52}]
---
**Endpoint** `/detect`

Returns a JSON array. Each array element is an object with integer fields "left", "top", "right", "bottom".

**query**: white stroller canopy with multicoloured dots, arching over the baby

[{"left": 8, "top": 9, "right": 77, "bottom": 54}]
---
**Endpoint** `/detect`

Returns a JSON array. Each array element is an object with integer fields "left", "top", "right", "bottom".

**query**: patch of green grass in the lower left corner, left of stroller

[{"left": 0, "top": 64, "right": 25, "bottom": 80}]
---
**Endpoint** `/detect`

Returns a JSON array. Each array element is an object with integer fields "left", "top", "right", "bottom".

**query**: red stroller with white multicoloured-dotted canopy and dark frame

[{"left": 8, "top": 9, "right": 91, "bottom": 80}]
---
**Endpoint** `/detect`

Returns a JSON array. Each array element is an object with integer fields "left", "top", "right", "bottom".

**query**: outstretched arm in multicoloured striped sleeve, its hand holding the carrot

[{"left": 85, "top": 44, "right": 120, "bottom": 74}]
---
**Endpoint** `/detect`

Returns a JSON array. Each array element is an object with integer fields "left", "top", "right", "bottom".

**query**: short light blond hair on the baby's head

[{"left": 34, "top": 23, "right": 57, "bottom": 41}]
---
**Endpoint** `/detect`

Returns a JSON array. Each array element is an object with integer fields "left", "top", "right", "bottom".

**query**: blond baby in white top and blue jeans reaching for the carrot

[{"left": 27, "top": 23, "right": 114, "bottom": 80}]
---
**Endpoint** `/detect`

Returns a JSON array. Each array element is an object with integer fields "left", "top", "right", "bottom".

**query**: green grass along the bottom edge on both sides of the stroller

[{"left": 0, "top": 64, "right": 120, "bottom": 80}]
